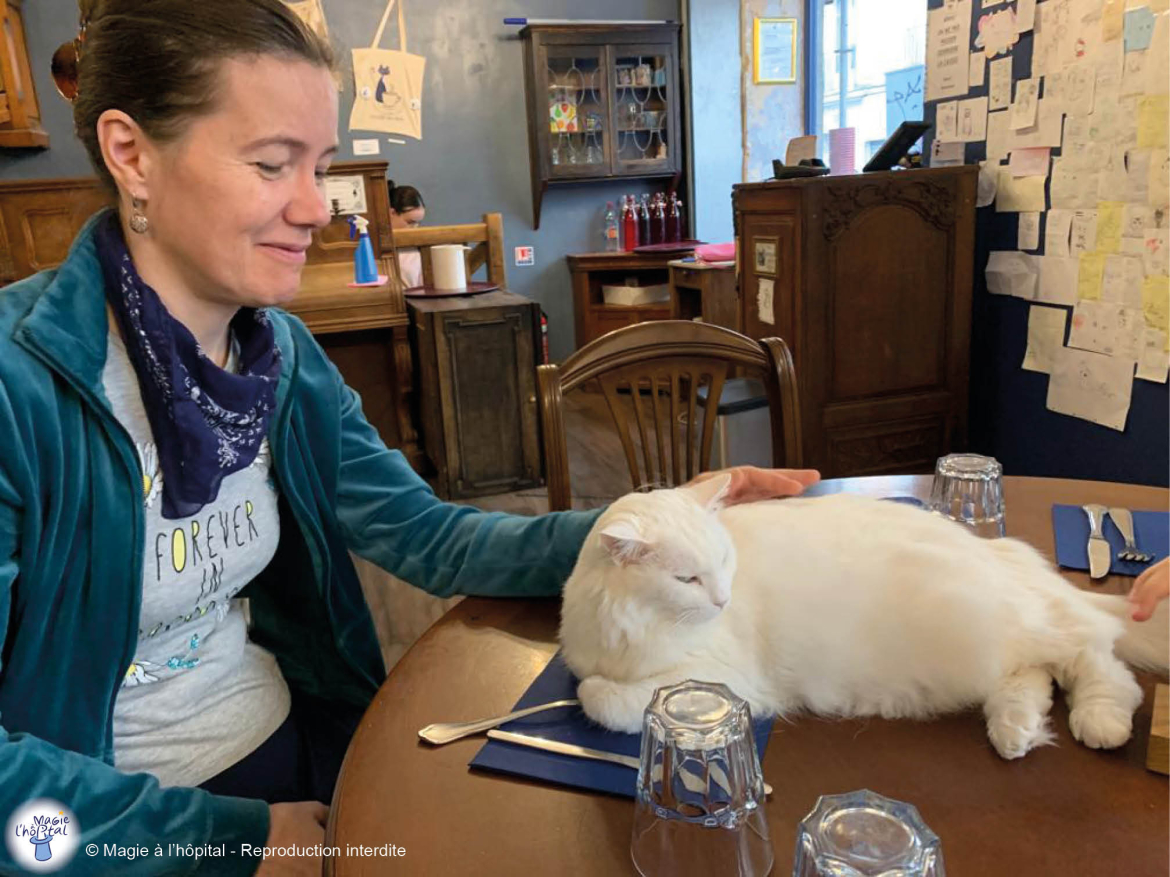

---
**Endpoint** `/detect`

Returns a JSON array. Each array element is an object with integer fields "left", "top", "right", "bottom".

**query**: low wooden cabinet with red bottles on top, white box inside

[{"left": 566, "top": 251, "right": 673, "bottom": 347}]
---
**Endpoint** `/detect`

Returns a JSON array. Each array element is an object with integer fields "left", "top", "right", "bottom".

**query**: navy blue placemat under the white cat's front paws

[{"left": 470, "top": 651, "right": 773, "bottom": 797}]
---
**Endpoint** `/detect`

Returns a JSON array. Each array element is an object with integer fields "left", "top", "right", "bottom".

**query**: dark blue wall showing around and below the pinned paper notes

[{"left": 927, "top": 0, "right": 1170, "bottom": 486}]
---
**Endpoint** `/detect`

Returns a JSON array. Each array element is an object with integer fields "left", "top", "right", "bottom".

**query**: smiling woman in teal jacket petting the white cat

[{"left": 0, "top": 0, "right": 817, "bottom": 875}]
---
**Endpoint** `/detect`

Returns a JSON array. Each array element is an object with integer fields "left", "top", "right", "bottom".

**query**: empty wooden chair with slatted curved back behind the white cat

[{"left": 537, "top": 320, "right": 804, "bottom": 511}]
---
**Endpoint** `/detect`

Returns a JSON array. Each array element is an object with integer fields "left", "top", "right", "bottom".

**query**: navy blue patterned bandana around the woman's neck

[{"left": 96, "top": 212, "right": 281, "bottom": 518}]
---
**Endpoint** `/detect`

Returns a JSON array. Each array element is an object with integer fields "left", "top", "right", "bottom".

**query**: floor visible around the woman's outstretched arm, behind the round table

[{"left": 353, "top": 392, "right": 632, "bottom": 669}]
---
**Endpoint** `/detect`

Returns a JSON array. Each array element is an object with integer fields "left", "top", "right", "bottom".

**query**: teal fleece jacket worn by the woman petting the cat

[{"left": 0, "top": 217, "right": 597, "bottom": 877}]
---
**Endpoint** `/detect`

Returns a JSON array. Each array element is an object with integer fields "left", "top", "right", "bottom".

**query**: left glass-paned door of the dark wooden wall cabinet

[{"left": 542, "top": 46, "right": 611, "bottom": 178}]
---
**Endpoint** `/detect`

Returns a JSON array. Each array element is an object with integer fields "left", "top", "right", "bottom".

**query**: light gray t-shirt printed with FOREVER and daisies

[{"left": 102, "top": 327, "right": 289, "bottom": 786}]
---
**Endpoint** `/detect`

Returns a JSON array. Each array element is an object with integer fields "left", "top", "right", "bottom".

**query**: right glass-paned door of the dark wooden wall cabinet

[{"left": 610, "top": 46, "right": 679, "bottom": 173}]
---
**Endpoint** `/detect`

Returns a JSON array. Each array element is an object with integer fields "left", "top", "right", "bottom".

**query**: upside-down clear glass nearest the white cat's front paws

[{"left": 631, "top": 681, "right": 773, "bottom": 877}]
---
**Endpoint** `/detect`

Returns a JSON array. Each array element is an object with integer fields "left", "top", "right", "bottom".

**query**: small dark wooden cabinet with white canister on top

[{"left": 407, "top": 290, "right": 541, "bottom": 499}]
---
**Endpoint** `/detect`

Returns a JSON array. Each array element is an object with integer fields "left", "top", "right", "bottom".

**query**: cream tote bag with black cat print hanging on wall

[{"left": 350, "top": 0, "right": 427, "bottom": 140}]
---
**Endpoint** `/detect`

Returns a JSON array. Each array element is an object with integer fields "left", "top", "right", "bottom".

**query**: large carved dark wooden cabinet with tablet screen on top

[{"left": 732, "top": 167, "right": 978, "bottom": 477}]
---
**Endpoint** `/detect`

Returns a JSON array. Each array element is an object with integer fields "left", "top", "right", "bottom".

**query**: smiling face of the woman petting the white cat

[{"left": 145, "top": 56, "right": 337, "bottom": 308}]
